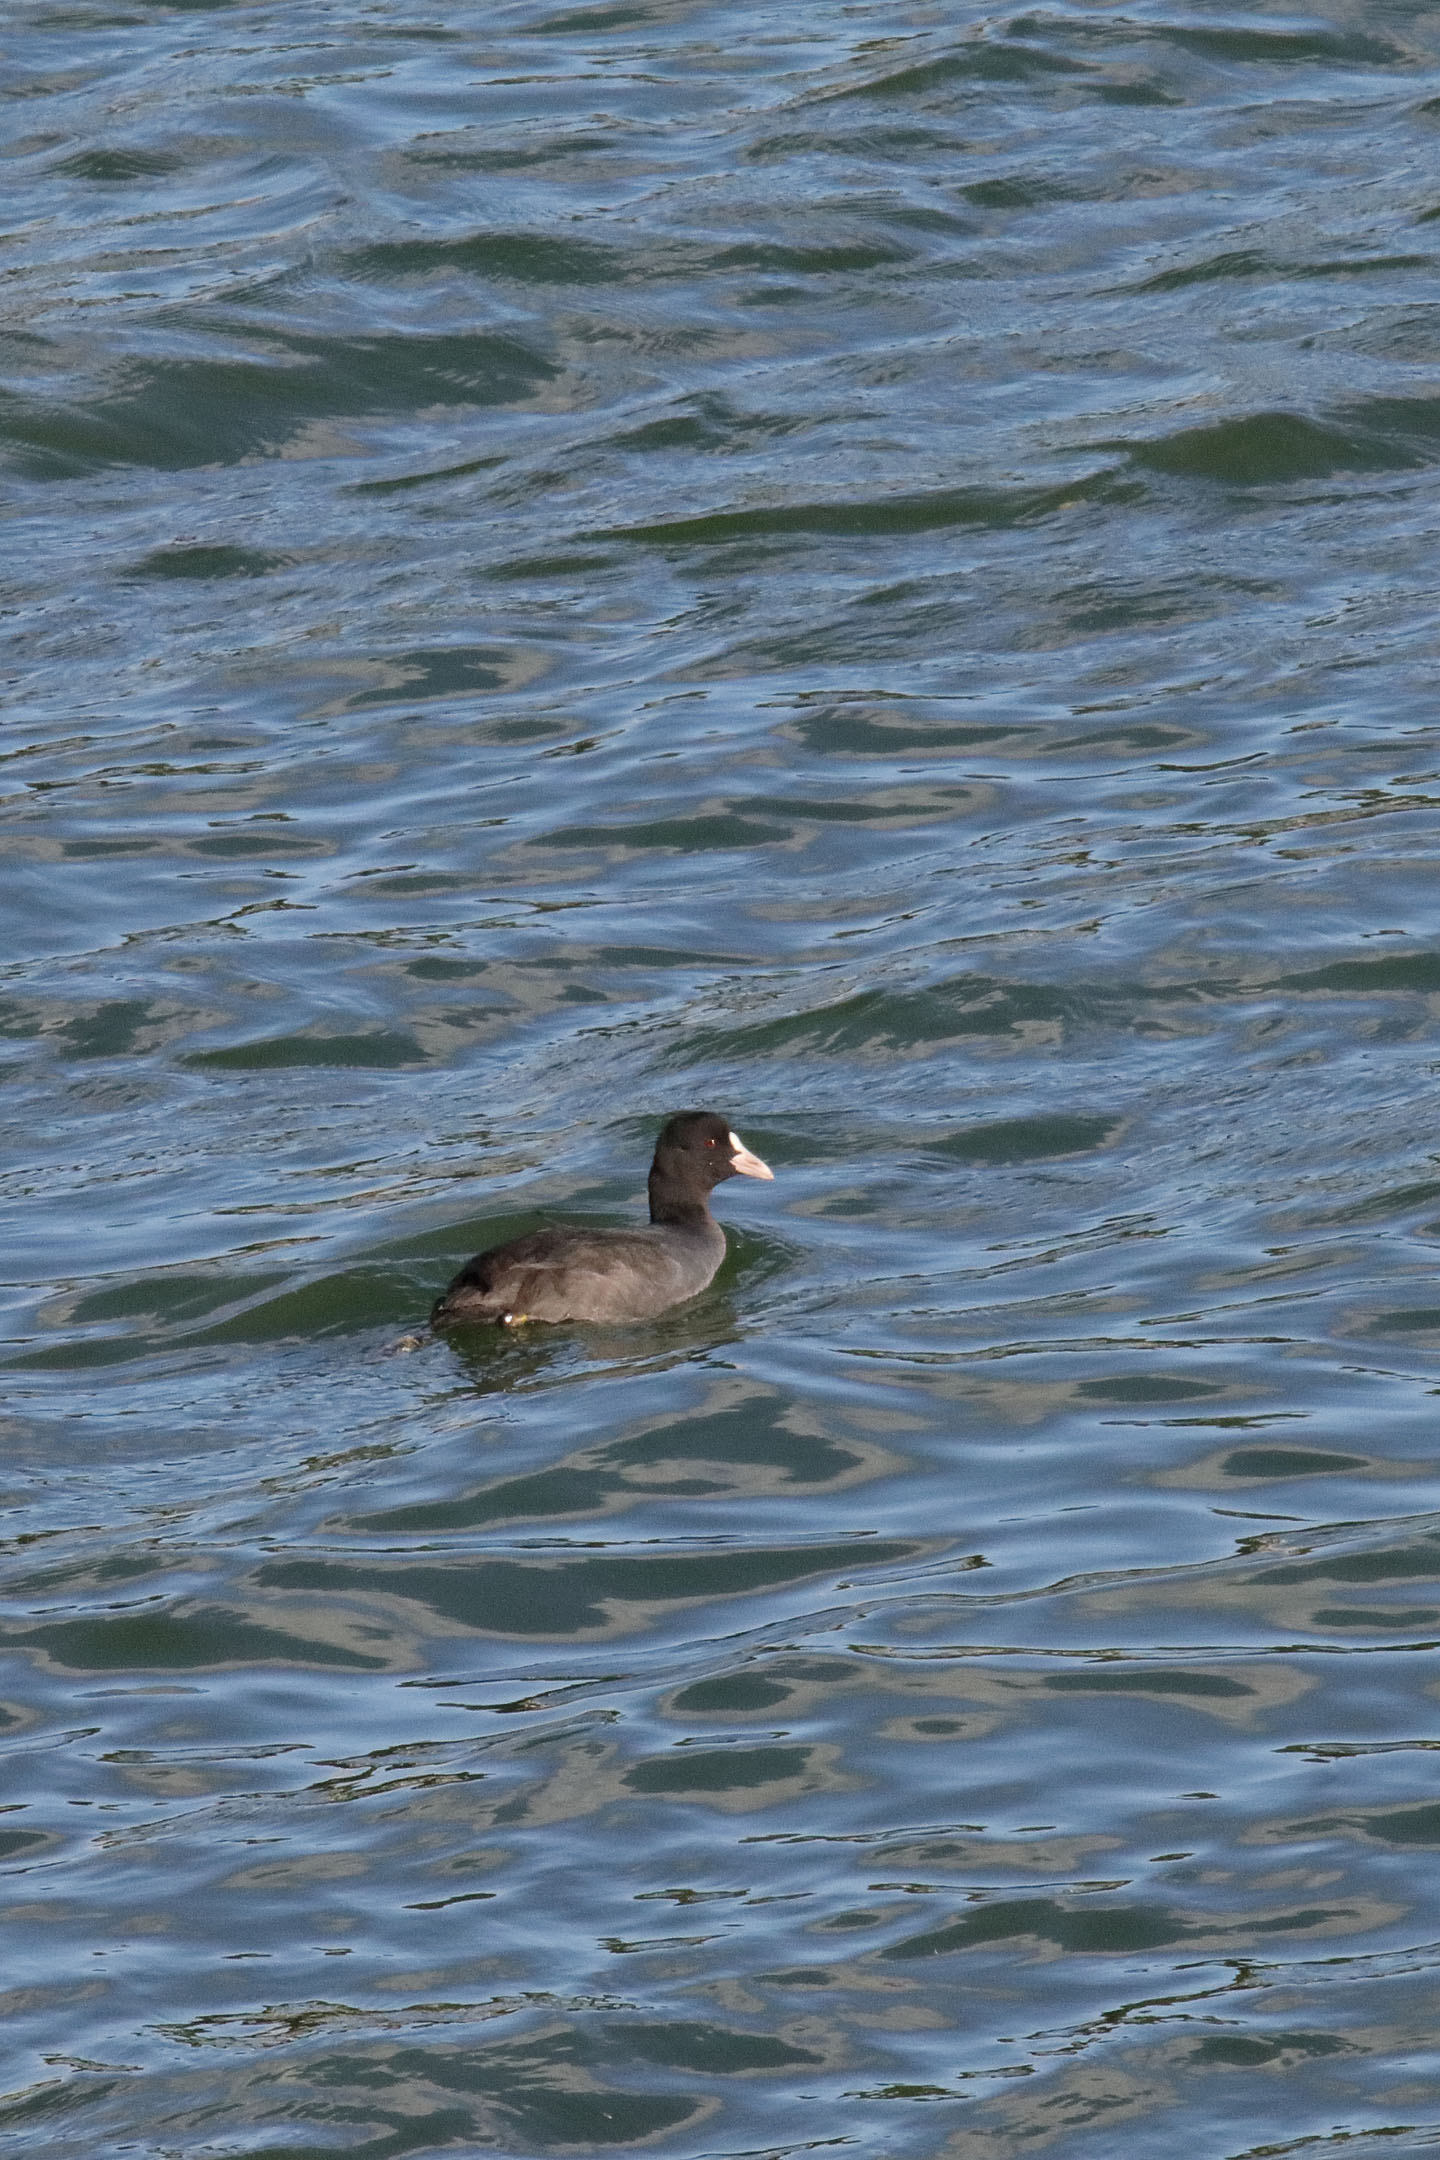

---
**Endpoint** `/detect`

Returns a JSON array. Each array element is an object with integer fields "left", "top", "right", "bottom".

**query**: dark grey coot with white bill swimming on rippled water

[{"left": 430, "top": 1110, "right": 775, "bottom": 1328}]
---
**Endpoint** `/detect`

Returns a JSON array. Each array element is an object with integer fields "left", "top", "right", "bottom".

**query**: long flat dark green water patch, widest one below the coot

[{"left": 257, "top": 1540, "right": 924, "bottom": 1635}]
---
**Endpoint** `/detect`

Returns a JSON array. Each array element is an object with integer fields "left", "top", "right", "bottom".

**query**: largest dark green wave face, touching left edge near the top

[{"left": 0, "top": 330, "right": 559, "bottom": 480}]
